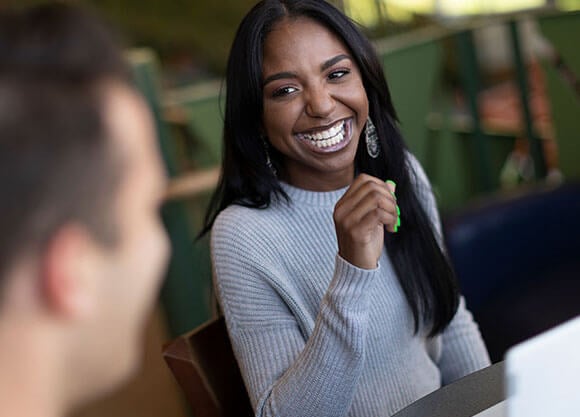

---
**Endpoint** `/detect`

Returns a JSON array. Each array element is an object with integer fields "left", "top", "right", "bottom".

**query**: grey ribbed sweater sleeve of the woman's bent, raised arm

[{"left": 211, "top": 211, "right": 378, "bottom": 417}]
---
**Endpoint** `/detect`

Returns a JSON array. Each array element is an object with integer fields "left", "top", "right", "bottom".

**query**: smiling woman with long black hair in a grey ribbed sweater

[{"left": 198, "top": 0, "right": 489, "bottom": 417}]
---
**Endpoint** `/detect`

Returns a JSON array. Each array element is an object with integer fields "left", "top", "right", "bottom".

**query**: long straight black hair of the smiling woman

[{"left": 201, "top": 0, "right": 459, "bottom": 336}]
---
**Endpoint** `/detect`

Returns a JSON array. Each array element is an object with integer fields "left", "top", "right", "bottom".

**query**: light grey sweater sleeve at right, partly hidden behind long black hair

[{"left": 409, "top": 154, "right": 490, "bottom": 385}]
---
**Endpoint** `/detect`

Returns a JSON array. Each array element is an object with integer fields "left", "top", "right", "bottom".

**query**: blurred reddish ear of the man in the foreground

[{"left": 40, "top": 224, "right": 99, "bottom": 319}]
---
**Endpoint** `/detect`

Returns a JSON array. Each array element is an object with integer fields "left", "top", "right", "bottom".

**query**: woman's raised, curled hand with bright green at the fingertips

[{"left": 334, "top": 174, "right": 398, "bottom": 269}]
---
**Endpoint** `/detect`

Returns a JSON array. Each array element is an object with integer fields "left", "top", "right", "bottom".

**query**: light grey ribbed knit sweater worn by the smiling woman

[{"left": 211, "top": 157, "right": 489, "bottom": 417}]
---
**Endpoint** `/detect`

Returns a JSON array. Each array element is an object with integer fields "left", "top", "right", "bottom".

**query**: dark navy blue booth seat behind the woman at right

[{"left": 444, "top": 183, "right": 580, "bottom": 362}]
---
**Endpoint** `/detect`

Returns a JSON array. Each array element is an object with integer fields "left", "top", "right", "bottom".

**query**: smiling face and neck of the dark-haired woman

[{"left": 262, "top": 18, "right": 368, "bottom": 191}]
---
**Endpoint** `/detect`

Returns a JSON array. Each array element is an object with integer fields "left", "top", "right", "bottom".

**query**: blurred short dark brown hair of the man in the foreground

[{"left": 0, "top": 4, "right": 129, "bottom": 285}]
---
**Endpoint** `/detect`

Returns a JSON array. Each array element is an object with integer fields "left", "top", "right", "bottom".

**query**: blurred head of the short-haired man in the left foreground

[{"left": 0, "top": 5, "right": 168, "bottom": 407}]
